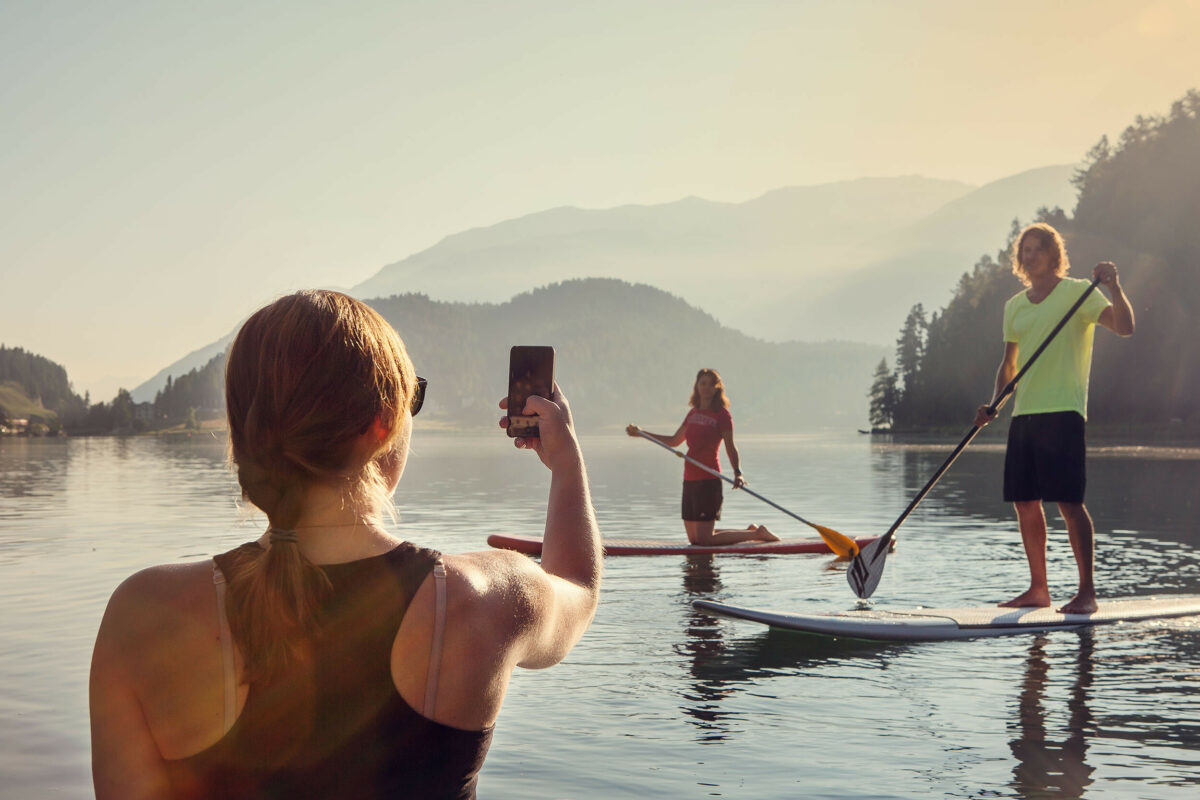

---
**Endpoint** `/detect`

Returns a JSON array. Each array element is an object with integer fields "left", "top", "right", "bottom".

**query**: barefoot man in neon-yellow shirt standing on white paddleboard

[{"left": 974, "top": 222, "right": 1134, "bottom": 614}]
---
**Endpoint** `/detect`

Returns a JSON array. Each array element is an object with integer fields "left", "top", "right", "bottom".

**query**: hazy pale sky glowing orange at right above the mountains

[{"left": 7, "top": 0, "right": 1200, "bottom": 399}]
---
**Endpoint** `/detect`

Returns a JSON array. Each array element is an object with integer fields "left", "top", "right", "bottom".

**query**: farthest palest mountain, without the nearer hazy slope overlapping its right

[{"left": 352, "top": 176, "right": 971, "bottom": 316}]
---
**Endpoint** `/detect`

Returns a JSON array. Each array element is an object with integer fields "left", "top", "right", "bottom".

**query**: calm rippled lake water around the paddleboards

[{"left": 0, "top": 431, "right": 1200, "bottom": 799}]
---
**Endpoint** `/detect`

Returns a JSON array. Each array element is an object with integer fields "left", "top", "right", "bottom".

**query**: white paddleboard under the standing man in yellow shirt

[{"left": 691, "top": 595, "right": 1200, "bottom": 642}]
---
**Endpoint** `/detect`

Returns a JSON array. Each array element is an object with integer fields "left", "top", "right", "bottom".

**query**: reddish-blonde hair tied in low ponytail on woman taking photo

[{"left": 226, "top": 291, "right": 416, "bottom": 682}]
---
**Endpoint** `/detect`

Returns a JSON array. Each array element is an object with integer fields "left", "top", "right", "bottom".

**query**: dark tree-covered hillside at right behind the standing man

[{"left": 870, "top": 90, "right": 1200, "bottom": 432}]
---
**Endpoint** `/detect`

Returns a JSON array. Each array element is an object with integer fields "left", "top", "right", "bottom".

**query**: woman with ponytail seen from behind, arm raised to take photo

[{"left": 90, "top": 291, "right": 601, "bottom": 800}]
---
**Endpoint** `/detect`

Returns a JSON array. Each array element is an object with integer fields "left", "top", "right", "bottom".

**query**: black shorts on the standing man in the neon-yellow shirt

[{"left": 1004, "top": 411, "right": 1087, "bottom": 503}]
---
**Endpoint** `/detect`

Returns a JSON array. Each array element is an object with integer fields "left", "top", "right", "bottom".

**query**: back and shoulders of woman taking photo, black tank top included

[{"left": 92, "top": 527, "right": 564, "bottom": 799}]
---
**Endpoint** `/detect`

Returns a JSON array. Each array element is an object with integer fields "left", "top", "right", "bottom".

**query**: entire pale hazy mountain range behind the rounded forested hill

[{"left": 352, "top": 166, "right": 1074, "bottom": 343}]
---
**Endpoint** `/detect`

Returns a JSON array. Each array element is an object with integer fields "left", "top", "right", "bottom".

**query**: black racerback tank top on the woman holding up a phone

[{"left": 167, "top": 542, "right": 492, "bottom": 800}]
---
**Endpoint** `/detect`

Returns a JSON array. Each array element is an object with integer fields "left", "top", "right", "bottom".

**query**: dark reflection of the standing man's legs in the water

[{"left": 1009, "top": 630, "right": 1096, "bottom": 799}]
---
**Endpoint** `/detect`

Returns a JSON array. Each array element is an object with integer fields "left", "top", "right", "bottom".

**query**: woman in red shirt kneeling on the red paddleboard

[{"left": 625, "top": 369, "right": 779, "bottom": 545}]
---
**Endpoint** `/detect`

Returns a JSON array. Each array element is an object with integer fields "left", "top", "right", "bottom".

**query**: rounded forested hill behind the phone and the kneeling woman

[{"left": 138, "top": 278, "right": 887, "bottom": 432}]
